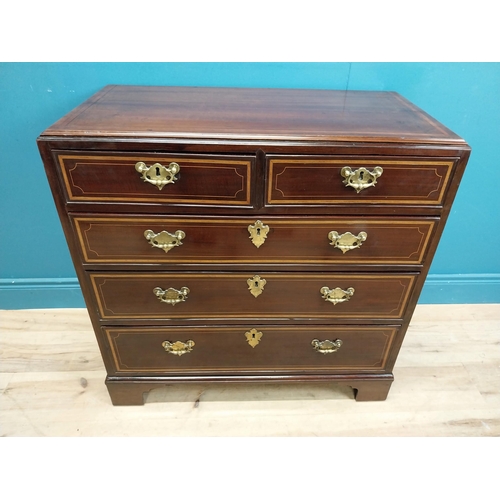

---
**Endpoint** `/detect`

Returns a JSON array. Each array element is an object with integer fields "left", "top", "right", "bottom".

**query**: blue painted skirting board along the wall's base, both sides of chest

[{"left": 0, "top": 274, "right": 500, "bottom": 309}]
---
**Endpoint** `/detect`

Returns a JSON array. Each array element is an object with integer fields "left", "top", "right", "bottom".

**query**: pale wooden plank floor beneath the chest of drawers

[{"left": 0, "top": 304, "right": 500, "bottom": 437}]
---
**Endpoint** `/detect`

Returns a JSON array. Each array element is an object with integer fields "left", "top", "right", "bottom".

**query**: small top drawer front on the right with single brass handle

[{"left": 267, "top": 157, "right": 454, "bottom": 206}]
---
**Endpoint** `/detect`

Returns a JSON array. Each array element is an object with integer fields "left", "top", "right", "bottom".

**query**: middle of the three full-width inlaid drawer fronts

[{"left": 90, "top": 273, "right": 416, "bottom": 321}]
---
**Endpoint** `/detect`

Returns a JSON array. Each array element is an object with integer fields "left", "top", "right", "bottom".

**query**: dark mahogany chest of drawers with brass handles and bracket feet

[{"left": 38, "top": 85, "right": 470, "bottom": 405}]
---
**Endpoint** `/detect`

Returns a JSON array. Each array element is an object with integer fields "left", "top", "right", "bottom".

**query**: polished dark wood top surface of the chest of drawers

[{"left": 45, "top": 86, "right": 463, "bottom": 144}]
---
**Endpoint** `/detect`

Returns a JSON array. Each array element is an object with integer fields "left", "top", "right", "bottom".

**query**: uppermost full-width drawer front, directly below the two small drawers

[{"left": 73, "top": 216, "right": 437, "bottom": 265}]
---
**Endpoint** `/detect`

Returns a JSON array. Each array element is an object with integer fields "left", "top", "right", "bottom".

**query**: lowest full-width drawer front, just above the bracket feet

[{"left": 103, "top": 326, "right": 397, "bottom": 375}]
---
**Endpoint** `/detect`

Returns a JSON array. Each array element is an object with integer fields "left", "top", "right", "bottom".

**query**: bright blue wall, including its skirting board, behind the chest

[{"left": 0, "top": 63, "right": 500, "bottom": 309}]
